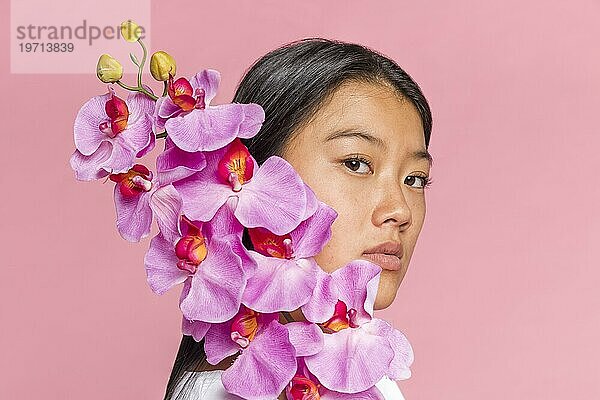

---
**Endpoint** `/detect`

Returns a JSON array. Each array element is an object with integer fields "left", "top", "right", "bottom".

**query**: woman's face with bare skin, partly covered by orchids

[{"left": 282, "top": 81, "right": 431, "bottom": 309}]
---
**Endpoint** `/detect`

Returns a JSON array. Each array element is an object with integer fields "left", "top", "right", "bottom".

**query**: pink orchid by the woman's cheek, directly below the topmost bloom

[{"left": 173, "top": 138, "right": 316, "bottom": 235}]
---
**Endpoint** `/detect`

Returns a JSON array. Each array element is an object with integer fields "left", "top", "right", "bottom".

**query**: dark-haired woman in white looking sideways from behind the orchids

[{"left": 165, "top": 38, "right": 432, "bottom": 400}]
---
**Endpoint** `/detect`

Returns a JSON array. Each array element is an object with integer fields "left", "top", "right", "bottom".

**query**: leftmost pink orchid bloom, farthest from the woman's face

[{"left": 70, "top": 86, "right": 155, "bottom": 181}]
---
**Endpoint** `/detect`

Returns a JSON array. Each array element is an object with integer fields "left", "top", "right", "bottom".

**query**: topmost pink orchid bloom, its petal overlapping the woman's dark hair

[{"left": 154, "top": 69, "right": 265, "bottom": 152}]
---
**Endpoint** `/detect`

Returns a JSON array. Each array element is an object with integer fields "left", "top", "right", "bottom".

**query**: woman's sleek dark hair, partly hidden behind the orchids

[{"left": 164, "top": 38, "right": 432, "bottom": 400}]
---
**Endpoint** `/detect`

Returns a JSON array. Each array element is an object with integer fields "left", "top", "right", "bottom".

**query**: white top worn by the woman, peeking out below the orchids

[{"left": 173, "top": 370, "right": 405, "bottom": 400}]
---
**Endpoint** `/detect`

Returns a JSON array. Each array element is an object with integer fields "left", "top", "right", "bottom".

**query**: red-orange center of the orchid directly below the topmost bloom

[{"left": 217, "top": 138, "right": 254, "bottom": 192}]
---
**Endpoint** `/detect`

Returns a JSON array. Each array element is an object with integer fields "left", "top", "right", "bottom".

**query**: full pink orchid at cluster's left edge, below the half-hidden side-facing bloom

[{"left": 144, "top": 185, "right": 256, "bottom": 323}]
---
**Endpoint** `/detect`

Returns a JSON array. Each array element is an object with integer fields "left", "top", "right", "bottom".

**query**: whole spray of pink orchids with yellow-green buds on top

[{"left": 70, "top": 21, "right": 413, "bottom": 400}]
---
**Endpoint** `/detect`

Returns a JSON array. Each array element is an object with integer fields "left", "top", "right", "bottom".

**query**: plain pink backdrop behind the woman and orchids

[{"left": 0, "top": 0, "right": 600, "bottom": 400}]
